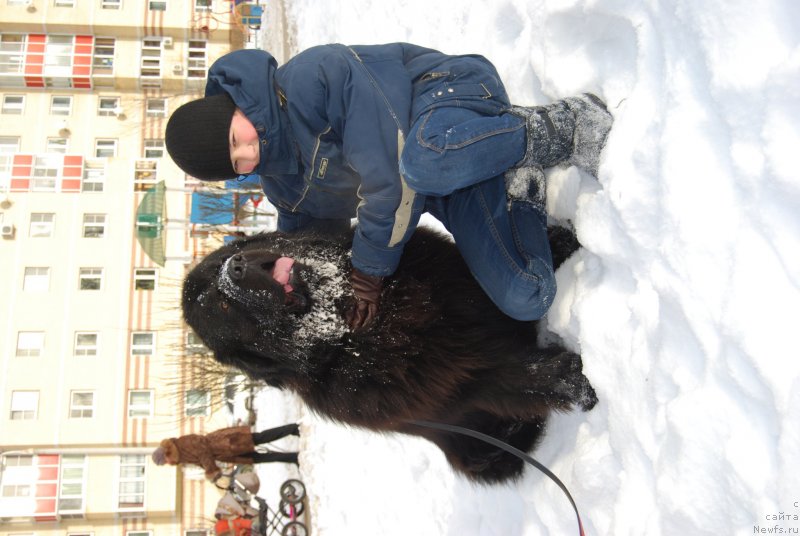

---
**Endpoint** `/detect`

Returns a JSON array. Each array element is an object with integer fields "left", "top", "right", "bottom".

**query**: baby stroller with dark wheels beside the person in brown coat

[{"left": 214, "top": 466, "right": 308, "bottom": 536}]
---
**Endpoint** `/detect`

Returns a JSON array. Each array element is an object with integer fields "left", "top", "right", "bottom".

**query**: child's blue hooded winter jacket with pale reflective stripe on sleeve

[{"left": 206, "top": 43, "right": 505, "bottom": 276}]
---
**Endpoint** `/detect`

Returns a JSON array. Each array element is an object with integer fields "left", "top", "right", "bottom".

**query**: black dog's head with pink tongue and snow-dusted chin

[{"left": 182, "top": 233, "right": 349, "bottom": 379}]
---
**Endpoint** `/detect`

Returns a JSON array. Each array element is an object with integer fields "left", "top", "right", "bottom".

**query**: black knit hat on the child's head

[{"left": 165, "top": 93, "right": 237, "bottom": 181}]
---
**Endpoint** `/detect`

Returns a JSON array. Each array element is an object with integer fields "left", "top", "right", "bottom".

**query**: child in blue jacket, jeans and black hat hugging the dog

[{"left": 166, "top": 43, "right": 612, "bottom": 330}]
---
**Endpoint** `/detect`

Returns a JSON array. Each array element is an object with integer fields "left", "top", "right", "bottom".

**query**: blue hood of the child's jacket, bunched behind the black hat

[{"left": 206, "top": 49, "right": 298, "bottom": 175}]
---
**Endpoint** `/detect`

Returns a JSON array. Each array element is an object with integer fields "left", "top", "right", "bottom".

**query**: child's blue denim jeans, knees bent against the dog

[{"left": 400, "top": 103, "right": 556, "bottom": 320}]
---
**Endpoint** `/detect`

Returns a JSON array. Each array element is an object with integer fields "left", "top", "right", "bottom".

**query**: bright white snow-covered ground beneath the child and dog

[{"left": 259, "top": 0, "right": 800, "bottom": 536}]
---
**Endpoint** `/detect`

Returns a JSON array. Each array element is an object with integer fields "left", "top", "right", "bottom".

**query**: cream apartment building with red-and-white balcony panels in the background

[{"left": 0, "top": 0, "right": 258, "bottom": 536}]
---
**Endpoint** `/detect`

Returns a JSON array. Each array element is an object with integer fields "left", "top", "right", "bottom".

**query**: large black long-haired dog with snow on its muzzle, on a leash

[{"left": 182, "top": 228, "right": 597, "bottom": 483}]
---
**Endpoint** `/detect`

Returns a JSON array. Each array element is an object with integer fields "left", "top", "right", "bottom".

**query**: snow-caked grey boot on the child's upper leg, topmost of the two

[{"left": 508, "top": 93, "right": 614, "bottom": 177}]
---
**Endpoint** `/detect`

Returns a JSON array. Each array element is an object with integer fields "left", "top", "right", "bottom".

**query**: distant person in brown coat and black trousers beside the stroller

[{"left": 152, "top": 423, "right": 300, "bottom": 480}]
